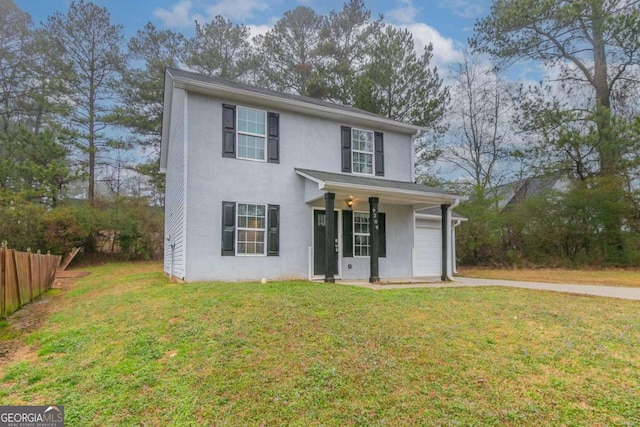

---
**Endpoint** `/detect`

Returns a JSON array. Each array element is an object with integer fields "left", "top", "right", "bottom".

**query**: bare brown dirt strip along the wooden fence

[{"left": 0, "top": 271, "right": 91, "bottom": 377}]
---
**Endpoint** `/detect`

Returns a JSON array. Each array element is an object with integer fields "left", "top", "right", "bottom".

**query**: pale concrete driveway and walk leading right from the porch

[{"left": 337, "top": 277, "right": 640, "bottom": 301}]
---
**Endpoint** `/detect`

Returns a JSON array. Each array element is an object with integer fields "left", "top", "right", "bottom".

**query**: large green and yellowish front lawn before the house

[{"left": 0, "top": 263, "right": 640, "bottom": 426}]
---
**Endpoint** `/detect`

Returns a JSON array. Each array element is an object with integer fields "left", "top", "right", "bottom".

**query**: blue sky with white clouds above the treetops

[{"left": 14, "top": 0, "right": 491, "bottom": 68}]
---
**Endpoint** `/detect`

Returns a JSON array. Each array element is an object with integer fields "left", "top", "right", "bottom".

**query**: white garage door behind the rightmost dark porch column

[{"left": 413, "top": 221, "right": 442, "bottom": 277}]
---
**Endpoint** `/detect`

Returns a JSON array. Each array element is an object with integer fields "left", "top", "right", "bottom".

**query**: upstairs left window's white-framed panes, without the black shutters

[{"left": 237, "top": 106, "right": 267, "bottom": 161}]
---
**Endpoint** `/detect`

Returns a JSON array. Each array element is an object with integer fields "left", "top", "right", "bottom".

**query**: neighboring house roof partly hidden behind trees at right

[{"left": 498, "top": 172, "right": 567, "bottom": 210}]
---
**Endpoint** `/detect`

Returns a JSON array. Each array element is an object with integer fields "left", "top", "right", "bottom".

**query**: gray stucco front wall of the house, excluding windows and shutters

[{"left": 174, "top": 93, "right": 413, "bottom": 281}]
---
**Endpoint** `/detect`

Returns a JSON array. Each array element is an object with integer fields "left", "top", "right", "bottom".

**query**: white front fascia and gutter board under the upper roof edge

[{"left": 174, "top": 77, "right": 425, "bottom": 135}]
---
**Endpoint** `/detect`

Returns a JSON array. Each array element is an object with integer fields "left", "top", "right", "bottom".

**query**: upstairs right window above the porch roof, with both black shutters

[{"left": 340, "top": 126, "right": 384, "bottom": 176}]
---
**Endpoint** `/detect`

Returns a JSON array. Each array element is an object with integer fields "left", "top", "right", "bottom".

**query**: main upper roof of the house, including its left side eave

[{"left": 160, "top": 67, "right": 426, "bottom": 171}]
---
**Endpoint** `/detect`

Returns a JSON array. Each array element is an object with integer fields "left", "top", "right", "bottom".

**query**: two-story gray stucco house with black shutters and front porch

[{"left": 160, "top": 68, "right": 462, "bottom": 282}]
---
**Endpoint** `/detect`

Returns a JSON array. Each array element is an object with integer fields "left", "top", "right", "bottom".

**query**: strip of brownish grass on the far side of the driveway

[{"left": 459, "top": 267, "right": 640, "bottom": 288}]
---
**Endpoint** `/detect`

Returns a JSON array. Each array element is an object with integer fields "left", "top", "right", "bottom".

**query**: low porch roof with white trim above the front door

[{"left": 296, "top": 168, "right": 467, "bottom": 205}]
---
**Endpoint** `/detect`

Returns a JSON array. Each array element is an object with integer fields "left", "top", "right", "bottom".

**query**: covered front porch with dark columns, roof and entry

[{"left": 296, "top": 169, "right": 465, "bottom": 283}]
